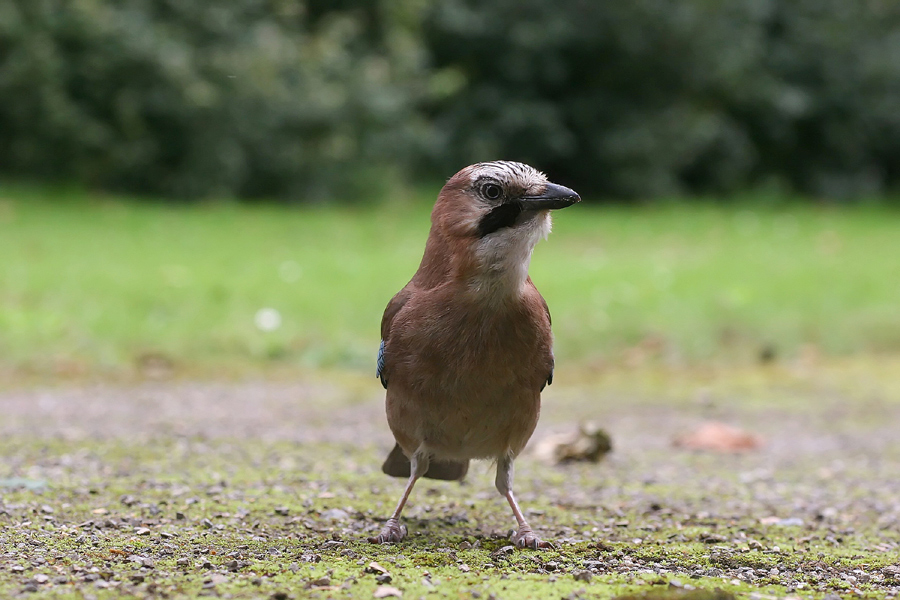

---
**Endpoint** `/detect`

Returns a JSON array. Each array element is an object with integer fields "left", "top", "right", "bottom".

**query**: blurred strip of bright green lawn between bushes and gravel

[{"left": 0, "top": 187, "right": 900, "bottom": 380}]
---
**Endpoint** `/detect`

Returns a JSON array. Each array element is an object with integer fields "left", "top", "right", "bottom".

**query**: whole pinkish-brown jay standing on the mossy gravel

[{"left": 369, "top": 161, "right": 581, "bottom": 549}]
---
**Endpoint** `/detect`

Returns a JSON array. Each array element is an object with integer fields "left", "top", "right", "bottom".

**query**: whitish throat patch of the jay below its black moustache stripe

[{"left": 470, "top": 212, "right": 551, "bottom": 302}]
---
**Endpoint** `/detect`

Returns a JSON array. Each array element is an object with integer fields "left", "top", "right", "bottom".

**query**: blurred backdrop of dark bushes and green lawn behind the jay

[{"left": 0, "top": 0, "right": 900, "bottom": 380}]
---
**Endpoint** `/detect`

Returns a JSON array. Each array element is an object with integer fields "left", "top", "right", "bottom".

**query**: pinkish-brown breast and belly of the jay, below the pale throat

[{"left": 385, "top": 280, "right": 553, "bottom": 459}]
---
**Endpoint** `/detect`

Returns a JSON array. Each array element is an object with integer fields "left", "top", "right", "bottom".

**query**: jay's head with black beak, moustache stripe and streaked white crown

[{"left": 431, "top": 161, "right": 581, "bottom": 290}]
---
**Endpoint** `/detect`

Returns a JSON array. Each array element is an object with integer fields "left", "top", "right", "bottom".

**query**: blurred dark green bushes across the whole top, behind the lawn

[{"left": 0, "top": 0, "right": 900, "bottom": 200}]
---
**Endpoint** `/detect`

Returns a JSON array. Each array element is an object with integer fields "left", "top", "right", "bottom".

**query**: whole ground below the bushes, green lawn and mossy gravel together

[{"left": 0, "top": 191, "right": 900, "bottom": 600}]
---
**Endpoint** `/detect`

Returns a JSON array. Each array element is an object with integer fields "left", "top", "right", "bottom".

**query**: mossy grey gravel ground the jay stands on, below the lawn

[{"left": 0, "top": 357, "right": 900, "bottom": 599}]
